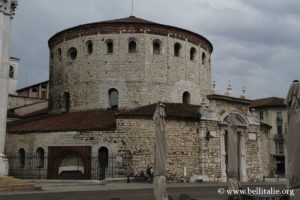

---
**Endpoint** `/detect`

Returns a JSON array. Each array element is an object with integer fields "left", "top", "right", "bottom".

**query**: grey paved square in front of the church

[{"left": 0, "top": 180, "right": 285, "bottom": 200}]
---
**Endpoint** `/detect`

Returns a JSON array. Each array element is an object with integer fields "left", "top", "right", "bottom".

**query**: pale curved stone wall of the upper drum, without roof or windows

[{"left": 50, "top": 33, "right": 211, "bottom": 111}]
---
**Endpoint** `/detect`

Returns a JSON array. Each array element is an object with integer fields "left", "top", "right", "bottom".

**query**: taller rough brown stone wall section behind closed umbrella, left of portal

[{"left": 118, "top": 119, "right": 200, "bottom": 179}]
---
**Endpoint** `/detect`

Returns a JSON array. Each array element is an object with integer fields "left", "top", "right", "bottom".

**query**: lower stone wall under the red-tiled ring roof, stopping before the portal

[{"left": 6, "top": 119, "right": 204, "bottom": 179}]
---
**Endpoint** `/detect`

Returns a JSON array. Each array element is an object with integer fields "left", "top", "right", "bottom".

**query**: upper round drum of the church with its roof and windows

[{"left": 49, "top": 16, "right": 213, "bottom": 112}]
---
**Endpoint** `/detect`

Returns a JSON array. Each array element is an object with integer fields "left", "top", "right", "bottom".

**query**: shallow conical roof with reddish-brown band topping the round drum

[{"left": 48, "top": 16, "right": 213, "bottom": 52}]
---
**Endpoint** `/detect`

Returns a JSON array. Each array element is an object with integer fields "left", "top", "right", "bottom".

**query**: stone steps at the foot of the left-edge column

[{"left": 0, "top": 176, "right": 40, "bottom": 192}]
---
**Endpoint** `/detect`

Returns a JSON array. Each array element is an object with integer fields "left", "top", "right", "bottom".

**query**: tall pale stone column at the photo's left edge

[{"left": 0, "top": 0, "right": 18, "bottom": 176}]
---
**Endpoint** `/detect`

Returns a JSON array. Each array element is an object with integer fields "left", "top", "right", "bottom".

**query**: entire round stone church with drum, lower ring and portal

[{"left": 5, "top": 16, "right": 270, "bottom": 182}]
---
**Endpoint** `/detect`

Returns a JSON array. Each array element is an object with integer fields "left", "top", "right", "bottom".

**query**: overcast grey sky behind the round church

[{"left": 12, "top": 0, "right": 300, "bottom": 99}]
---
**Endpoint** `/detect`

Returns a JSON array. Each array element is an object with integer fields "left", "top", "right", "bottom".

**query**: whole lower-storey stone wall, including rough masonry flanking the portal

[{"left": 6, "top": 119, "right": 264, "bottom": 182}]
